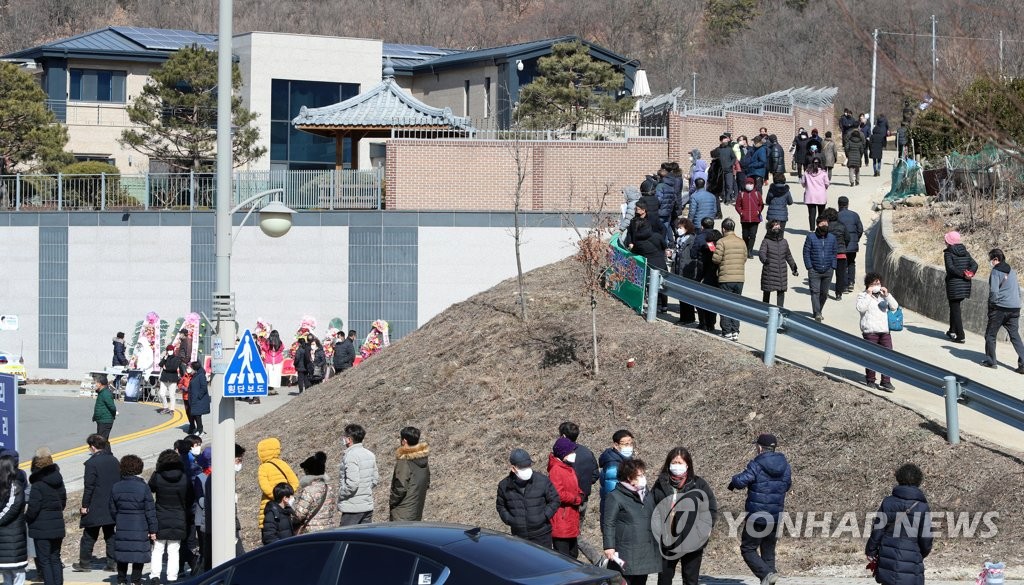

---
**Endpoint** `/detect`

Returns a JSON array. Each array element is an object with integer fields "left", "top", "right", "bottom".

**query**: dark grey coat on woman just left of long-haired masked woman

[{"left": 601, "top": 484, "right": 662, "bottom": 575}]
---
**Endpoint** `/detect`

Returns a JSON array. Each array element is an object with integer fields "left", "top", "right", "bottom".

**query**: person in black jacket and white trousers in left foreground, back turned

[{"left": 150, "top": 449, "right": 191, "bottom": 583}]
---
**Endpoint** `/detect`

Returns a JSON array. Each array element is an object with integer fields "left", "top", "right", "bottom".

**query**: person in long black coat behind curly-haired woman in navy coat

[{"left": 71, "top": 434, "right": 121, "bottom": 573}]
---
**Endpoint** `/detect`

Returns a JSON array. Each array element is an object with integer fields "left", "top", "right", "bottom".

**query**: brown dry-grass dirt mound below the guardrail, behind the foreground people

[{"left": 239, "top": 261, "right": 1024, "bottom": 576}]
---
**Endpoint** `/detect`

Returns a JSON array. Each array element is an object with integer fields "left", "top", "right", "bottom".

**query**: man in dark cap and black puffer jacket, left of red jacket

[{"left": 495, "top": 449, "right": 560, "bottom": 548}]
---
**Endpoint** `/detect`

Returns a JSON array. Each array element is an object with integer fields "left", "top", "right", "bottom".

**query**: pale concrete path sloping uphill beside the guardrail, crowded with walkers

[{"left": 670, "top": 152, "right": 1024, "bottom": 452}]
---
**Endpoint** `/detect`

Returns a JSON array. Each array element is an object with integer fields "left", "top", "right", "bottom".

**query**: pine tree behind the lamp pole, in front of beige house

[{"left": 120, "top": 46, "right": 266, "bottom": 171}]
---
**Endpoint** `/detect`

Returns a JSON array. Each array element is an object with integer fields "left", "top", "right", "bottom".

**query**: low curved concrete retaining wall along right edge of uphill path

[{"left": 870, "top": 211, "right": 1019, "bottom": 339}]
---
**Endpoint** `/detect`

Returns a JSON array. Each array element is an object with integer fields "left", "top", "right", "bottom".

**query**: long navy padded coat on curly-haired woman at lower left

[{"left": 111, "top": 475, "right": 158, "bottom": 562}]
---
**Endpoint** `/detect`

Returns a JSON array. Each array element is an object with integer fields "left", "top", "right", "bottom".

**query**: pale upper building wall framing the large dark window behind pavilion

[{"left": 232, "top": 32, "right": 383, "bottom": 170}]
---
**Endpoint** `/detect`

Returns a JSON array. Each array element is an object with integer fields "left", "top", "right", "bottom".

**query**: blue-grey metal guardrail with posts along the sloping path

[{"left": 646, "top": 268, "right": 1024, "bottom": 445}]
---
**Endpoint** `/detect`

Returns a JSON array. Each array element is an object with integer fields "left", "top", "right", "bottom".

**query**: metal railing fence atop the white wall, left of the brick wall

[{"left": 0, "top": 167, "right": 384, "bottom": 211}]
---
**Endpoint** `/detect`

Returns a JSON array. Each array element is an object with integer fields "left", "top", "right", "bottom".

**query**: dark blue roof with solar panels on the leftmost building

[{"left": 5, "top": 27, "right": 217, "bottom": 60}]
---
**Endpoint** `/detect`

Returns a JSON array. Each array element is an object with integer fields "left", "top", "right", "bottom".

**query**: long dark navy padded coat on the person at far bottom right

[{"left": 864, "top": 486, "right": 932, "bottom": 585}]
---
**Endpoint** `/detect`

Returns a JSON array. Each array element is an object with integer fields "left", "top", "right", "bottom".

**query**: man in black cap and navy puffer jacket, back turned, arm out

[{"left": 729, "top": 433, "right": 793, "bottom": 585}]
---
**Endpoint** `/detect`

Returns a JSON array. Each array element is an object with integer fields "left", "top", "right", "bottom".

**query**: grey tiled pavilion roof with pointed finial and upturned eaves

[{"left": 292, "top": 68, "right": 472, "bottom": 130}]
